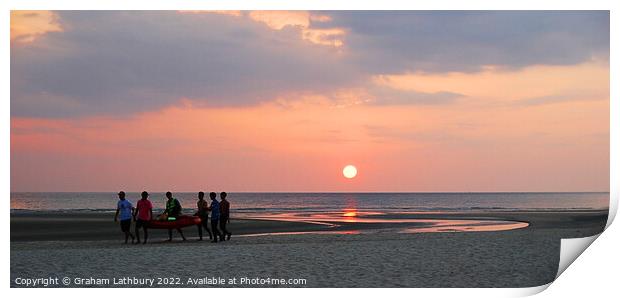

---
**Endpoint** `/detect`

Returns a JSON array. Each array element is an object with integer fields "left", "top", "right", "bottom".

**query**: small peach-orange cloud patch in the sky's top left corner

[{"left": 11, "top": 10, "right": 62, "bottom": 44}]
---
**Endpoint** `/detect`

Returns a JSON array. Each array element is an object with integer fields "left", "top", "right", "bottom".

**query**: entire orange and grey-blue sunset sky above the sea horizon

[{"left": 10, "top": 11, "right": 610, "bottom": 192}]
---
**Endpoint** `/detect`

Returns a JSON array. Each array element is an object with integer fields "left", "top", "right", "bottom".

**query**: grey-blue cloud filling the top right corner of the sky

[{"left": 324, "top": 11, "right": 609, "bottom": 73}]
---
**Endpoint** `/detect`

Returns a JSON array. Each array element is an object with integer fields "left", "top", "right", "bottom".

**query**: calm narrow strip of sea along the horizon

[{"left": 11, "top": 192, "right": 609, "bottom": 213}]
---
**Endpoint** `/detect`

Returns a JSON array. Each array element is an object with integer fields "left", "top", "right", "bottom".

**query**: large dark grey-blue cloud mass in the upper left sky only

[{"left": 11, "top": 12, "right": 360, "bottom": 117}]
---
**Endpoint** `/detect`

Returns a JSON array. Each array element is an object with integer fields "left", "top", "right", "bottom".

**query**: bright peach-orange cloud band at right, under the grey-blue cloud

[{"left": 372, "top": 61, "right": 609, "bottom": 103}]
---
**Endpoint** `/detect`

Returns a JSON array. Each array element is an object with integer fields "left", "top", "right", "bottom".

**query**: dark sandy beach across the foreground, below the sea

[{"left": 11, "top": 211, "right": 607, "bottom": 287}]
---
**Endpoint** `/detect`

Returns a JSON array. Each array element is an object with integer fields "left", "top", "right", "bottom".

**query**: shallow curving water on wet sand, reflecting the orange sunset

[{"left": 240, "top": 209, "right": 529, "bottom": 236}]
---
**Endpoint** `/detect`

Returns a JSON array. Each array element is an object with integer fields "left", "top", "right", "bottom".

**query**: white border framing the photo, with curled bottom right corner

[{"left": 0, "top": 0, "right": 620, "bottom": 297}]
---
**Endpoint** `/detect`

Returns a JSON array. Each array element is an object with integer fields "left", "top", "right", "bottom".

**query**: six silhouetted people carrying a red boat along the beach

[{"left": 114, "top": 191, "right": 232, "bottom": 244}]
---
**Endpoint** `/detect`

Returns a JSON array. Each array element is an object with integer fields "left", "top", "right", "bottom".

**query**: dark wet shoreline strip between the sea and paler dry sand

[{"left": 10, "top": 210, "right": 608, "bottom": 242}]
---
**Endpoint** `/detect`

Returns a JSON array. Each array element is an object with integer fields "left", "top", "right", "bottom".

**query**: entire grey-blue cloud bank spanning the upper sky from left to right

[{"left": 11, "top": 11, "right": 609, "bottom": 117}]
